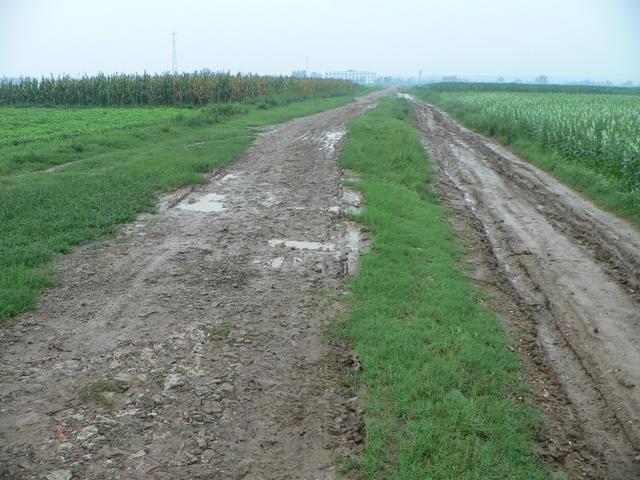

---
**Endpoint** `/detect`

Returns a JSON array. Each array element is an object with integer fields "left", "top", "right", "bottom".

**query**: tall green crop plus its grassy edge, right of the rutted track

[{"left": 411, "top": 84, "right": 640, "bottom": 225}]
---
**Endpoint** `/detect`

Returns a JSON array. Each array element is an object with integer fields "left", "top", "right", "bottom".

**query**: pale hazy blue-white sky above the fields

[{"left": 0, "top": 0, "right": 640, "bottom": 82}]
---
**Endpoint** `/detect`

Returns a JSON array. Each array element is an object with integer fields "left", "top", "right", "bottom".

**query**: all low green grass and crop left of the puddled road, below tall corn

[{"left": 0, "top": 90, "right": 364, "bottom": 324}]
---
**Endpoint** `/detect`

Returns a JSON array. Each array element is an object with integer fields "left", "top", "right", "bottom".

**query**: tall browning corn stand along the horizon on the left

[{"left": 0, "top": 73, "right": 356, "bottom": 106}]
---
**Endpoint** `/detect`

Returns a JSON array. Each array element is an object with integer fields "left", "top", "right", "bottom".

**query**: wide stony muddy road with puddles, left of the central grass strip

[{"left": 0, "top": 93, "right": 380, "bottom": 480}]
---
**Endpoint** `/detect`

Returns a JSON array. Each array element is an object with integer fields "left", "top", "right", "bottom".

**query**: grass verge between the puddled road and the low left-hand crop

[{"left": 0, "top": 96, "right": 364, "bottom": 323}]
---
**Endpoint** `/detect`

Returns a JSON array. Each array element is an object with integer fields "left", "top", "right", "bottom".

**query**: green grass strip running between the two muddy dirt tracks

[{"left": 336, "top": 95, "right": 546, "bottom": 480}]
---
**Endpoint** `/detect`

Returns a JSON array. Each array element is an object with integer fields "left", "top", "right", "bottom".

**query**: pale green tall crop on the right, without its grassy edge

[{"left": 430, "top": 92, "right": 640, "bottom": 192}]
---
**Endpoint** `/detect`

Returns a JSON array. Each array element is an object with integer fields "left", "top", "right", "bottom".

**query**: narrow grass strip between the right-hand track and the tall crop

[{"left": 411, "top": 88, "right": 640, "bottom": 227}]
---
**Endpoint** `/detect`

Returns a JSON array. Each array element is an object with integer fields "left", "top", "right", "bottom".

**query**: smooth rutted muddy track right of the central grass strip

[{"left": 412, "top": 100, "right": 640, "bottom": 479}]
